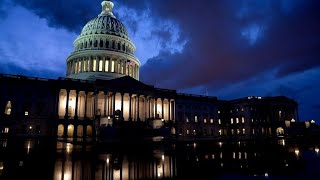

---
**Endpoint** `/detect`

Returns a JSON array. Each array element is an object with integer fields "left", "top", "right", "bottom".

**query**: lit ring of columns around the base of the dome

[{"left": 67, "top": 56, "right": 139, "bottom": 79}]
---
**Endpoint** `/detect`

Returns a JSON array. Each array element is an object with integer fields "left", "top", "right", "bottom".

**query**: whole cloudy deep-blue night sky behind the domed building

[{"left": 0, "top": 0, "right": 320, "bottom": 123}]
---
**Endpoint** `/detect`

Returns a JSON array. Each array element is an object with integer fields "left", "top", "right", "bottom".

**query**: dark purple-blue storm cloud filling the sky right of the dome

[{"left": 141, "top": 0, "right": 320, "bottom": 88}]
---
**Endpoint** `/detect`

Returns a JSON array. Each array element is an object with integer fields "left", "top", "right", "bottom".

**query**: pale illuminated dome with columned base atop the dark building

[{"left": 67, "top": 1, "right": 140, "bottom": 80}]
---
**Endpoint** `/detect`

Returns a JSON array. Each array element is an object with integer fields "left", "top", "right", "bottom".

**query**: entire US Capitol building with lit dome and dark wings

[{"left": 0, "top": 1, "right": 299, "bottom": 141}]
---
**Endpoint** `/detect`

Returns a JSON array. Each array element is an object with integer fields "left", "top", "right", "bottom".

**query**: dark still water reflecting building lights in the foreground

[{"left": 0, "top": 139, "right": 320, "bottom": 180}]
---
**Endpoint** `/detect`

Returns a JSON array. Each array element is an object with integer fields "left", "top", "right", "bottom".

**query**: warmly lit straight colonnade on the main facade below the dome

[{"left": 58, "top": 89, "right": 175, "bottom": 121}]
